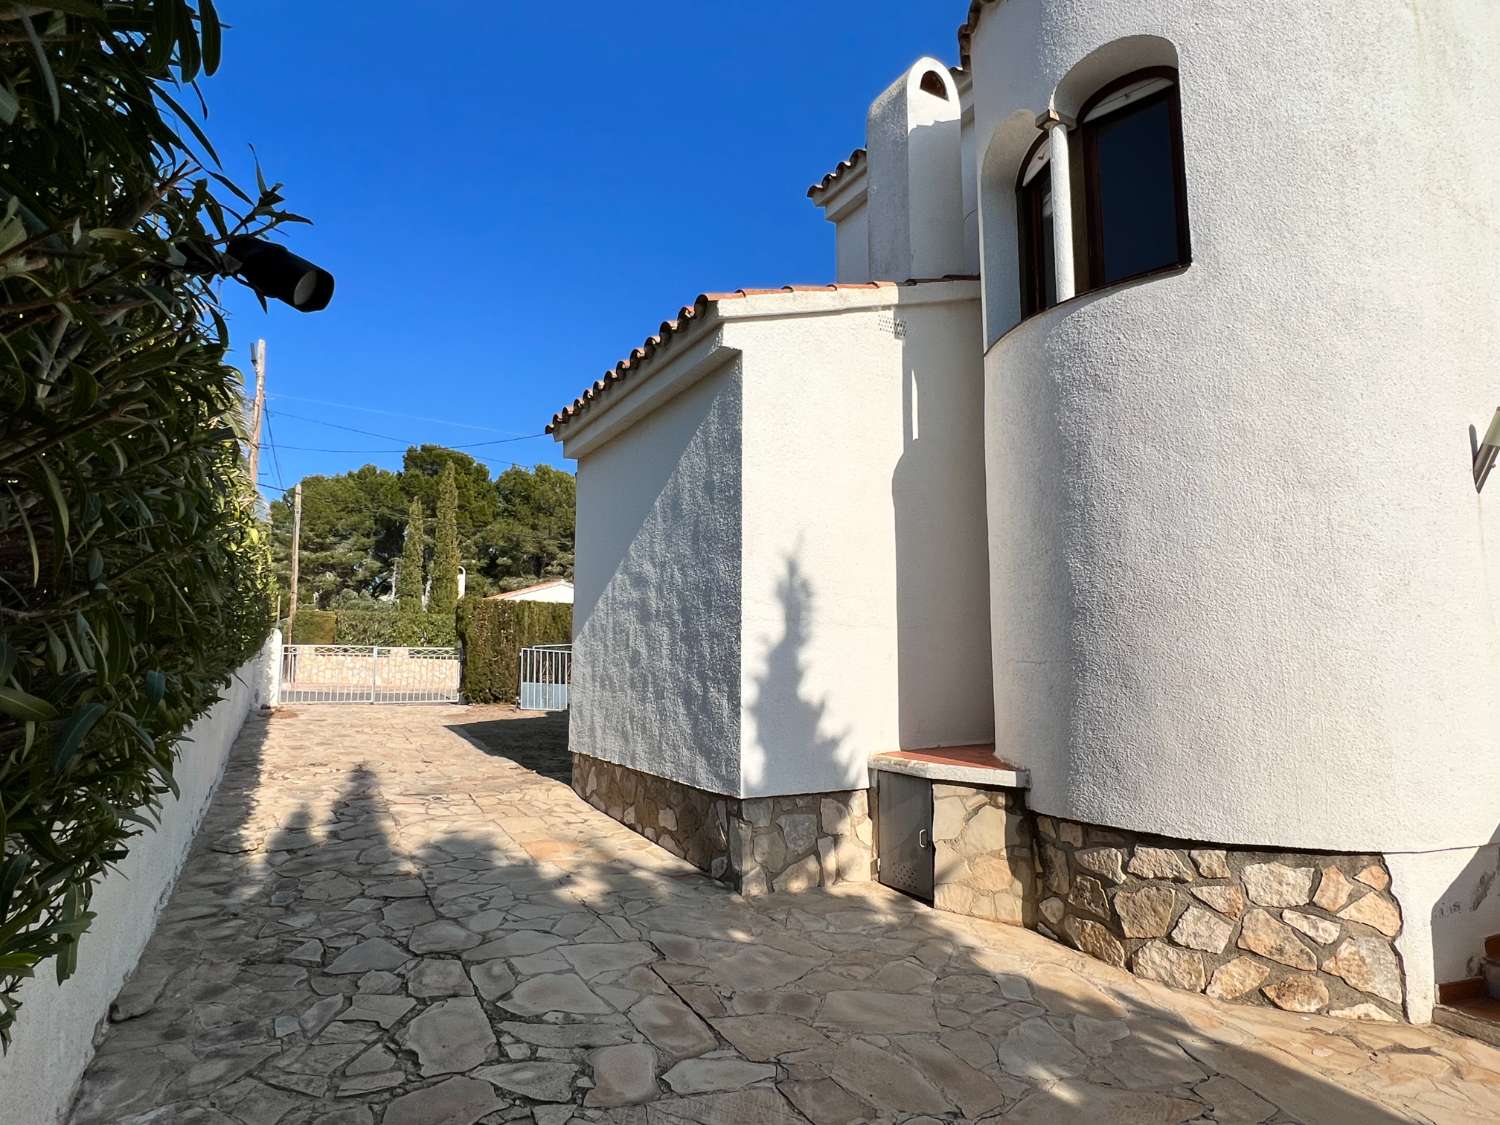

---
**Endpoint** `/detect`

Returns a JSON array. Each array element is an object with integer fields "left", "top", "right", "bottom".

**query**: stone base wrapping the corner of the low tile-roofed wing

[{"left": 573, "top": 755, "right": 875, "bottom": 896}]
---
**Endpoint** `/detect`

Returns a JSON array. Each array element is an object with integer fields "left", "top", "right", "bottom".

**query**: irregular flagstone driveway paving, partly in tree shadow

[{"left": 72, "top": 707, "right": 1500, "bottom": 1125}]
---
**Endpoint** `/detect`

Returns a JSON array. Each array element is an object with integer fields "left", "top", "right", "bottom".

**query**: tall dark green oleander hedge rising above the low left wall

[{"left": 0, "top": 0, "right": 306, "bottom": 1044}]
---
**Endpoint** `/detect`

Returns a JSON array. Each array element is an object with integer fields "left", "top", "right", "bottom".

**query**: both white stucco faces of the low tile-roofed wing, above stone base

[{"left": 567, "top": 282, "right": 993, "bottom": 797}]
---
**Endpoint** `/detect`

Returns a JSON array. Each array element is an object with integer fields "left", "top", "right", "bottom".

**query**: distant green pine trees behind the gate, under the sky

[{"left": 272, "top": 446, "right": 575, "bottom": 609}]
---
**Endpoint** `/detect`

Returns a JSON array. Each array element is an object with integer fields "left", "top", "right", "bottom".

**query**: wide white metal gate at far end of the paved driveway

[{"left": 281, "top": 645, "right": 459, "bottom": 704}]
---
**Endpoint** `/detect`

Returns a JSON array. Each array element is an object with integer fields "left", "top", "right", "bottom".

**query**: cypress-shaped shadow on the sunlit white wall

[{"left": 740, "top": 555, "right": 854, "bottom": 792}]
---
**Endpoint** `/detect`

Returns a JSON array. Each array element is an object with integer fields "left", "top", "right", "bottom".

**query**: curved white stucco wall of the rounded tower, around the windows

[{"left": 972, "top": 0, "right": 1500, "bottom": 852}]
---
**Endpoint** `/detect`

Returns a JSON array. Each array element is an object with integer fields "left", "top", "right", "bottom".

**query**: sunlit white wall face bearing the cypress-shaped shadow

[{"left": 738, "top": 282, "right": 993, "bottom": 795}]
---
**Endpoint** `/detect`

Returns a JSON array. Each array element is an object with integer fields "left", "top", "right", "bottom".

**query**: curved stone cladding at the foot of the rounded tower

[{"left": 1037, "top": 816, "right": 1404, "bottom": 1020}]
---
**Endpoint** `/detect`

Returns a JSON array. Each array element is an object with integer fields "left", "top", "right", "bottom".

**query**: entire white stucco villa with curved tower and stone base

[{"left": 551, "top": 0, "right": 1500, "bottom": 1038}]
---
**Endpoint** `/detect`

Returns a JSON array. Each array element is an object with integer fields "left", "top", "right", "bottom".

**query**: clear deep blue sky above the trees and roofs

[{"left": 206, "top": 0, "right": 968, "bottom": 498}]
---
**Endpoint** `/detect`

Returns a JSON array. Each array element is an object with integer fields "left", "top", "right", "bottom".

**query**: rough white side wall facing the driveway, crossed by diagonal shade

[{"left": 569, "top": 363, "right": 741, "bottom": 794}]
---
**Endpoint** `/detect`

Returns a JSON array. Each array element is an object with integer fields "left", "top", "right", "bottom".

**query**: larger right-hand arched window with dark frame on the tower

[{"left": 1077, "top": 68, "right": 1191, "bottom": 290}]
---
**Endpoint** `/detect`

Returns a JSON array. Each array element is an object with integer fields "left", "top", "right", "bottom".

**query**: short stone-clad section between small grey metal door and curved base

[{"left": 933, "top": 782, "right": 1038, "bottom": 927}]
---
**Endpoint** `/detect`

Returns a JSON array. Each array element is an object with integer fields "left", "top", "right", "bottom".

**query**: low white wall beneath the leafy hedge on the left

[{"left": 0, "top": 633, "right": 281, "bottom": 1125}]
